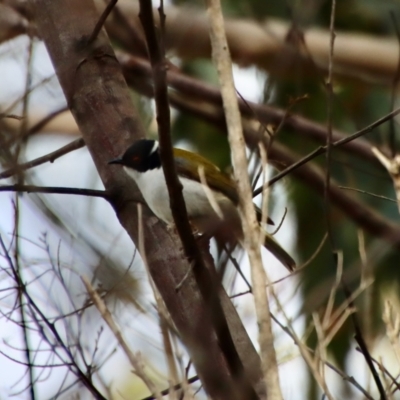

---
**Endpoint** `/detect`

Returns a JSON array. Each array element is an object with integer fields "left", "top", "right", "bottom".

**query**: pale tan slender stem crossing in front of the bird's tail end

[{"left": 207, "top": 0, "right": 282, "bottom": 399}]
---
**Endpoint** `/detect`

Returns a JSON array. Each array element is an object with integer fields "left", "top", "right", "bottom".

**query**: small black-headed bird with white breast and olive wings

[{"left": 109, "top": 139, "right": 296, "bottom": 271}]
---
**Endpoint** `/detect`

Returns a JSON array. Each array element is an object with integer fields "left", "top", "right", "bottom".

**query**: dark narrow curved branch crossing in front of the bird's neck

[{"left": 139, "top": 0, "right": 257, "bottom": 399}]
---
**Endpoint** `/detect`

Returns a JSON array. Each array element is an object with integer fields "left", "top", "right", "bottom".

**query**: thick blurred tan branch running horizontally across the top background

[{"left": 5, "top": 0, "right": 398, "bottom": 86}]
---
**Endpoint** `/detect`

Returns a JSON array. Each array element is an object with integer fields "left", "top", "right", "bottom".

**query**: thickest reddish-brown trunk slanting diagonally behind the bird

[{"left": 30, "top": 0, "right": 260, "bottom": 399}]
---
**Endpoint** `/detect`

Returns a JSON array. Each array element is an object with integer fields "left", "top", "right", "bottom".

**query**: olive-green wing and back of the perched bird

[{"left": 174, "top": 149, "right": 239, "bottom": 204}]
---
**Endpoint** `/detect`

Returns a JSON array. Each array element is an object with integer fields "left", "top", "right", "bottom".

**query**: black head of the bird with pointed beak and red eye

[{"left": 109, "top": 139, "right": 161, "bottom": 172}]
